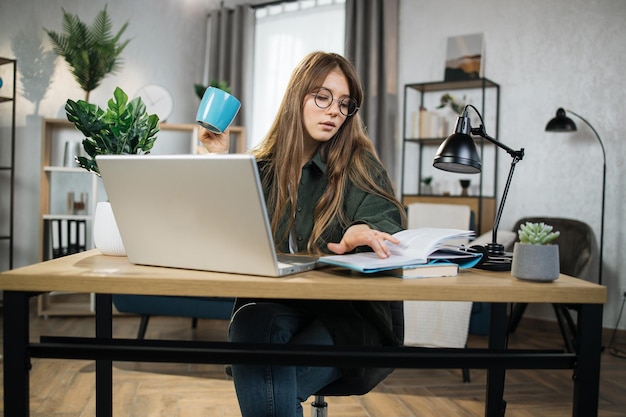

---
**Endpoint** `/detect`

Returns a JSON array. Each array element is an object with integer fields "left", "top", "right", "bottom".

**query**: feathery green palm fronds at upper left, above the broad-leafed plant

[{"left": 44, "top": 5, "right": 130, "bottom": 101}]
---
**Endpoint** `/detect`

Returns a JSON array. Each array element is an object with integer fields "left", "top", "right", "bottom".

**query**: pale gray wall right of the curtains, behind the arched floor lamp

[{"left": 398, "top": 0, "right": 626, "bottom": 328}]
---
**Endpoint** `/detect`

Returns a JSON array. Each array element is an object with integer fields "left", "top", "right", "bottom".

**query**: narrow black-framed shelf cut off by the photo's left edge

[{"left": 0, "top": 57, "right": 17, "bottom": 271}]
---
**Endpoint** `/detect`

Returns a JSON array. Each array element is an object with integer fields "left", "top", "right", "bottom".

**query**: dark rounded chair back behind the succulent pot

[{"left": 513, "top": 217, "right": 597, "bottom": 281}]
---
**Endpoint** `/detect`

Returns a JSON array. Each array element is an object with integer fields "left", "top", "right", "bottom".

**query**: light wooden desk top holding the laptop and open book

[{"left": 0, "top": 249, "right": 606, "bottom": 304}]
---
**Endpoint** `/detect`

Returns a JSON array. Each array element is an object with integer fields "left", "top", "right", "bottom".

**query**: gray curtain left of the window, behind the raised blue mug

[{"left": 204, "top": 5, "right": 255, "bottom": 135}]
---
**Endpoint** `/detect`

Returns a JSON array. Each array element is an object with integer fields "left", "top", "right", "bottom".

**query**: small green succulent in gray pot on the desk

[{"left": 511, "top": 222, "right": 560, "bottom": 281}]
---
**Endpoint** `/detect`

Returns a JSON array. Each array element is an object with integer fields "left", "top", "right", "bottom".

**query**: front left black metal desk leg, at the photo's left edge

[{"left": 3, "top": 291, "right": 30, "bottom": 417}]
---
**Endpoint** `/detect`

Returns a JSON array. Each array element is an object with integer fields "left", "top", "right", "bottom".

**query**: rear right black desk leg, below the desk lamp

[{"left": 485, "top": 303, "right": 508, "bottom": 417}]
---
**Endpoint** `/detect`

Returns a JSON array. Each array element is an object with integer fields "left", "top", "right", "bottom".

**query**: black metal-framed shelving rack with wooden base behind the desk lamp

[{"left": 400, "top": 78, "right": 500, "bottom": 234}]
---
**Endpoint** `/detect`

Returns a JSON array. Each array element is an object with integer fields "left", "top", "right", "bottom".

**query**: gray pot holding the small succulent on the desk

[{"left": 511, "top": 242, "right": 560, "bottom": 281}]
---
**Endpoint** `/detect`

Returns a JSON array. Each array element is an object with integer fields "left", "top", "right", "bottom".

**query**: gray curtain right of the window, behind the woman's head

[{"left": 345, "top": 0, "right": 399, "bottom": 176}]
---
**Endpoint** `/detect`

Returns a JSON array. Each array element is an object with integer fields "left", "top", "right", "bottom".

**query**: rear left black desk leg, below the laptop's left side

[{"left": 96, "top": 294, "right": 113, "bottom": 417}]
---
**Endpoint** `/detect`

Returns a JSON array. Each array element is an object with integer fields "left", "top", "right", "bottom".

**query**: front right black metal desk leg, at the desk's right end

[{"left": 572, "top": 304, "right": 602, "bottom": 417}]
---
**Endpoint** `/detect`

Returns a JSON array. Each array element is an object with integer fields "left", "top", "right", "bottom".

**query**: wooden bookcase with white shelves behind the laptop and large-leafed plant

[{"left": 38, "top": 119, "right": 246, "bottom": 316}]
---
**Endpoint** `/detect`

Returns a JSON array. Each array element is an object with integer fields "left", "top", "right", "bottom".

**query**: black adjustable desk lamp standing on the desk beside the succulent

[{"left": 433, "top": 104, "right": 524, "bottom": 271}]
